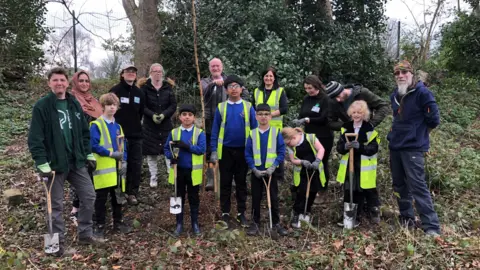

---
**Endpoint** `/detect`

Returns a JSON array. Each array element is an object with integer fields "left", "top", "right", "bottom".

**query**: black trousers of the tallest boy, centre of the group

[{"left": 219, "top": 146, "right": 248, "bottom": 214}]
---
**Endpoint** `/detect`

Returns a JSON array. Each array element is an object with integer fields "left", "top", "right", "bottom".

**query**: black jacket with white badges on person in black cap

[{"left": 110, "top": 80, "right": 145, "bottom": 139}]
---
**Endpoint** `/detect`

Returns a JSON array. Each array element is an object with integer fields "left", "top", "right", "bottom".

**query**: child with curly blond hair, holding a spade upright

[{"left": 337, "top": 100, "right": 380, "bottom": 227}]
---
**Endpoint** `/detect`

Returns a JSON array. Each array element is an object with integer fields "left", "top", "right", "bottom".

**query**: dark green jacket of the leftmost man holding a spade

[{"left": 28, "top": 92, "right": 92, "bottom": 173}]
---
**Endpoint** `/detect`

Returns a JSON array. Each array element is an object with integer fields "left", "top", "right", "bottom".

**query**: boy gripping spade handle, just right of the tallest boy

[{"left": 245, "top": 104, "right": 288, "bottom": 236}]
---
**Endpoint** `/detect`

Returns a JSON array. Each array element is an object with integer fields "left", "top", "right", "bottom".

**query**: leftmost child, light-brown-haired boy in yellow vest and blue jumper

[{"left": 90, "top": 93, "right": 131, "bottom": 239}]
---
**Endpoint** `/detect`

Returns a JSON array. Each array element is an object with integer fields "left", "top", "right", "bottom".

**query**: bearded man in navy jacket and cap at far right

[{"left": 387, "top": 61, "right": 440, "bottom": 236}]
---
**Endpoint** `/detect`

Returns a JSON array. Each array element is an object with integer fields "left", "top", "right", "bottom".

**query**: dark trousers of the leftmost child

[{"left": 95, "top": 187, "right": 122, "bottom": 225}]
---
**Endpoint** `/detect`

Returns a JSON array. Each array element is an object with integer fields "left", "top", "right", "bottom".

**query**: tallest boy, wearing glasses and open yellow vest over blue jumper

[{"left": 210, "top": 75, "right": 257, "bottom": 227}]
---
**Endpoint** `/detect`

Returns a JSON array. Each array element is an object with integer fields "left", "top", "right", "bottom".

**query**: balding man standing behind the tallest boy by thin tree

[{"left": 200, "top": 58, "right": 249, "bottom": 190}]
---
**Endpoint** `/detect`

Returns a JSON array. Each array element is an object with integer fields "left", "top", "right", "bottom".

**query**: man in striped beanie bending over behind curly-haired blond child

[{"left": 327, "top": 81, "right": 389, "bottom": 131}]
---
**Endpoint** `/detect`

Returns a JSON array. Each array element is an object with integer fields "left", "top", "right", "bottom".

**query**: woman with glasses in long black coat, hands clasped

[{"left": 141, "top": 63, "right": 177, "bottom": 187}]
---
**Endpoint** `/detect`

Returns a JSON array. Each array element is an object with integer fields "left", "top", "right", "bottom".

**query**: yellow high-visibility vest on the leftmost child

[{"left": 90, "top": 118, "right": 125, "bottom": 192}]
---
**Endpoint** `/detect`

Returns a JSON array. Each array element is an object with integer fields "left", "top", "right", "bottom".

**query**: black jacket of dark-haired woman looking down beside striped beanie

[{"left": 298, "top": 92, "right": 333, "bottom": 138}]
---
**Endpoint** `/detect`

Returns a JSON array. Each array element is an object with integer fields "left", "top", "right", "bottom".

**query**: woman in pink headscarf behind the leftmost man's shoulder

[{"left": 70, "top": 70, "right": 103, "bottom": 222}]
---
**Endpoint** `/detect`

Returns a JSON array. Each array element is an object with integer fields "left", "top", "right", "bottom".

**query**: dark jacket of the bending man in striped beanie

[{"left": 328, "top": 84, "right": 390, "bottom": 131}]
